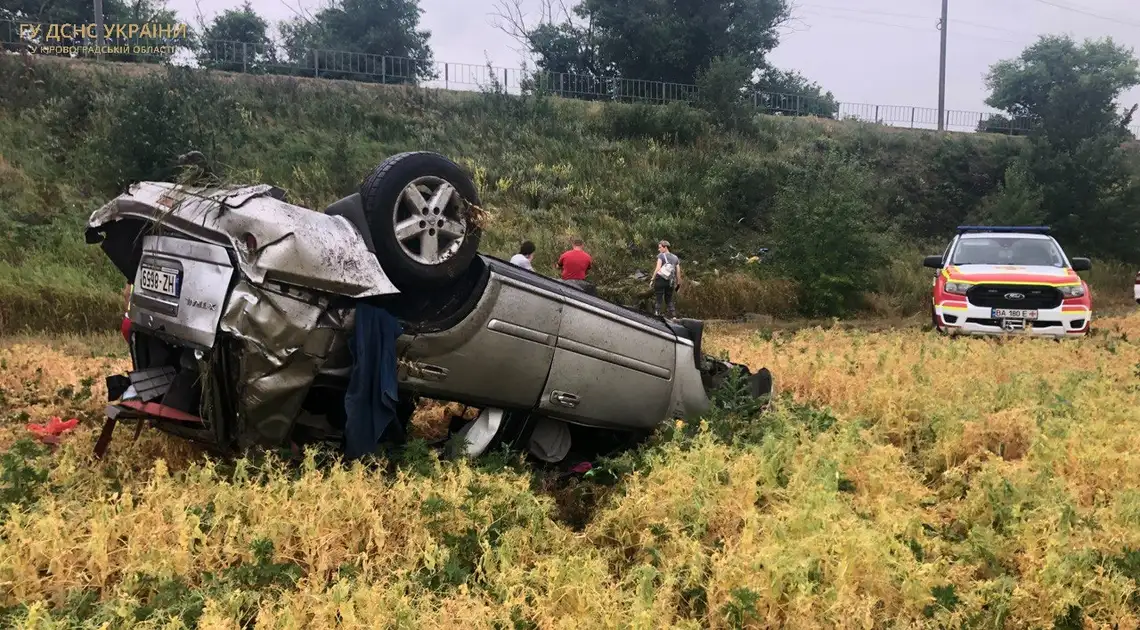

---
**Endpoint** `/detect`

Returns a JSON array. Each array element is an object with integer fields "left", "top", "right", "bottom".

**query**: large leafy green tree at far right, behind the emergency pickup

[{"left": 986, "top": 36, "right": 1140, "bottom": 261}]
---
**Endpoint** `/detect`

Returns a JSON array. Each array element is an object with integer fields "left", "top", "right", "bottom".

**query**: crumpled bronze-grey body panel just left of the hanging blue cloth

[{"left": 221, "top": 279, "right": 352, "bottom": 448}]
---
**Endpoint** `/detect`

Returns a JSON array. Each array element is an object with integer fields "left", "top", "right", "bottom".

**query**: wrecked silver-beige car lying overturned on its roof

[{"left": 87, "top": 152, "right": 772, "bottom": 461}]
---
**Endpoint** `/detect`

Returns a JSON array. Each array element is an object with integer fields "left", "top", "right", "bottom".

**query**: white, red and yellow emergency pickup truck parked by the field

[{"left": 923, "top": 226, "right": 1092, "bottom": 337}]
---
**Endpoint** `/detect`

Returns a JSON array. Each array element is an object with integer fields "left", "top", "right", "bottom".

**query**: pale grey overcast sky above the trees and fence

[{"left": 169, "top": 0, "right": 1140, "bottom": 117}]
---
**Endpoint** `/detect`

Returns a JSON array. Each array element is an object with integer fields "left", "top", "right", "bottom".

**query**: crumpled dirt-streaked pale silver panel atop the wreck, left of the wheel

[{"left": 88, "top": 181, "right": 399, "bottom": 297}]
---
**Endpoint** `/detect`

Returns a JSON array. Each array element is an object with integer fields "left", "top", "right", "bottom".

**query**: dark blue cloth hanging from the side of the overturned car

[{"left": 344, "top": 304, "right": 404, "bottom": 459}]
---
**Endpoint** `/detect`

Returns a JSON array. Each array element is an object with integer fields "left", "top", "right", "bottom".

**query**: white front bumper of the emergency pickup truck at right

[{"left": 935, "top": 302, "right": 1092, "bottom": 337}]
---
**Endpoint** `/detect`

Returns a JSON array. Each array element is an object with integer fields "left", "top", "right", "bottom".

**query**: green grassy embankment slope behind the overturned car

[{"left": 0, "top": 57, "right": 1133, "bottom": 333}]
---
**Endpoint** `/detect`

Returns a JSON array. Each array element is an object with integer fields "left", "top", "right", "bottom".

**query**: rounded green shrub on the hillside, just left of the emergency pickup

[{"left": 772, "top": 150, "right": 887, "bottom": 317}]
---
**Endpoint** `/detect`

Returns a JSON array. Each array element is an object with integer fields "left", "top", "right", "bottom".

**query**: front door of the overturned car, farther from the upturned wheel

[{"left": 538, "top": 286, "right": 677, "bottom": 428}]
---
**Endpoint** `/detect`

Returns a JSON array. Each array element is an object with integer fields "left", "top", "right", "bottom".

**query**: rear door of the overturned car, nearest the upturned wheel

[{"left": 401, "top": 260, "right": 562, "bottom": 410}]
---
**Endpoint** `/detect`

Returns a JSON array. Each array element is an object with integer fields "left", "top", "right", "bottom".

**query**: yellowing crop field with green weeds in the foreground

[{"left": 0, "top": 314, "right": 1140, "bottom": 629}]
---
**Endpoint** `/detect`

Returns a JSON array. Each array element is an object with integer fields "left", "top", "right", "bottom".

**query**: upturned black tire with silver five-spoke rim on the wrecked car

[{"left": 360, "top": 152, "right": 482, "bottom": 291}]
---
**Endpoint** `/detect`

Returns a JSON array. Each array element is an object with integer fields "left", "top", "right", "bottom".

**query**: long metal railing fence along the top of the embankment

[{"left": 0, "top": 22, "right": 1140, "bottom": 136}]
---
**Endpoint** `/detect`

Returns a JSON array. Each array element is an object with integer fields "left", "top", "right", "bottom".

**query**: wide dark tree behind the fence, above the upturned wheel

[{"left": 280, "top": 0, "right": 435, "bottom": 83}]
